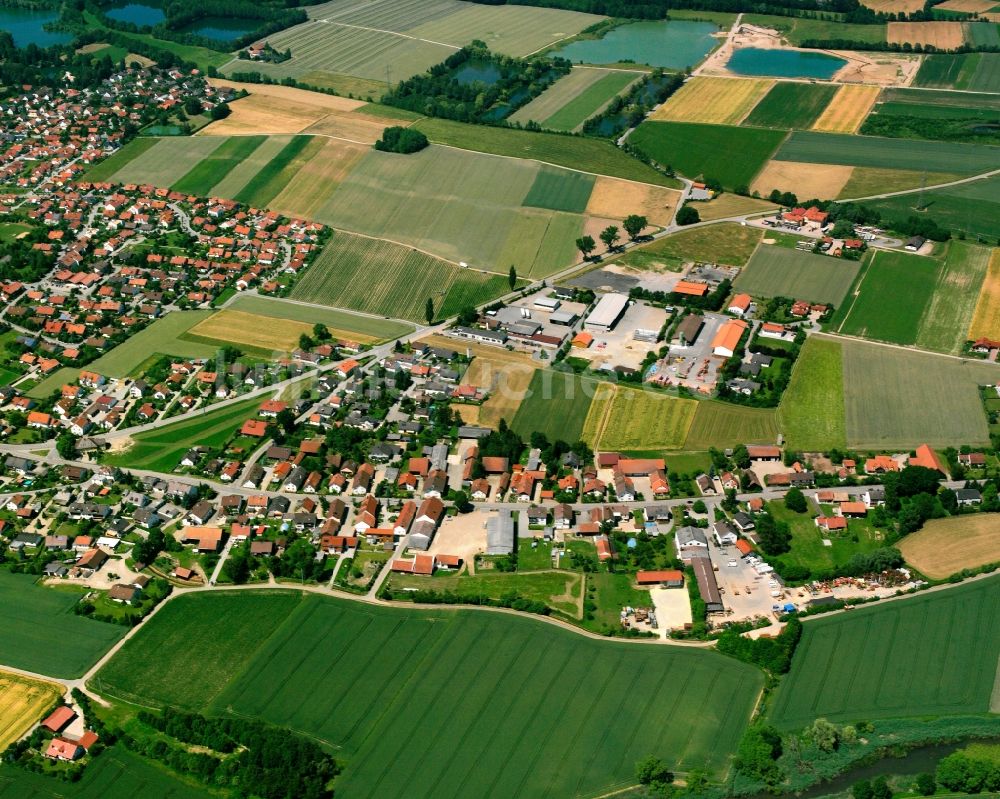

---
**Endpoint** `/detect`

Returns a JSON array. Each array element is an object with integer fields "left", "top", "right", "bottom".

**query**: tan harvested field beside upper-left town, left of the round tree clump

[{"left": 199, "top": 78, "right": 374, "bottom": 141}]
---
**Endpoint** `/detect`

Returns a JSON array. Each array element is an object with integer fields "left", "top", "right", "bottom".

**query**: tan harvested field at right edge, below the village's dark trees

[{"left": 899, "top": 513, "right": 1000, "bottom": 580}]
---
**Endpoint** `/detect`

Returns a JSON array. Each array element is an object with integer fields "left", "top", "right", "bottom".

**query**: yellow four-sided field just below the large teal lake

[{"left": 652, "top": 77, "right": 774, "bottom": 125}]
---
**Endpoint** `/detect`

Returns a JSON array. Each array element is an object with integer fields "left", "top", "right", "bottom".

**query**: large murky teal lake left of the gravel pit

[{"left": 552, "top": 19, "right": 719, "bottom": 69}]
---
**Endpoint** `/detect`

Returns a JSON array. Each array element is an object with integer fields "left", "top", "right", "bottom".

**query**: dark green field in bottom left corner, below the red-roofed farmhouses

[{"left": 0, "top": 745, "right": 213, "bottom": 799}]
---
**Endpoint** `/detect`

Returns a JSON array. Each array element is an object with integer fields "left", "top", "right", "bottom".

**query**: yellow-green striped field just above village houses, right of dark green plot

[{"left": 584, "top": 385, "right": 698, "bottom": 451}]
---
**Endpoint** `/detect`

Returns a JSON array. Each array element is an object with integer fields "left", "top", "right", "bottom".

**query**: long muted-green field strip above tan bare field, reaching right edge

[{"left": 774, "top": 130, "right": 1000, "bottom": 174}]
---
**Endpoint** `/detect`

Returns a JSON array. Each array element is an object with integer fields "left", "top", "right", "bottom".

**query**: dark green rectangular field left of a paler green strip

[{"left": 838, "top": 250, "right": 940, "bottom": 344}]
